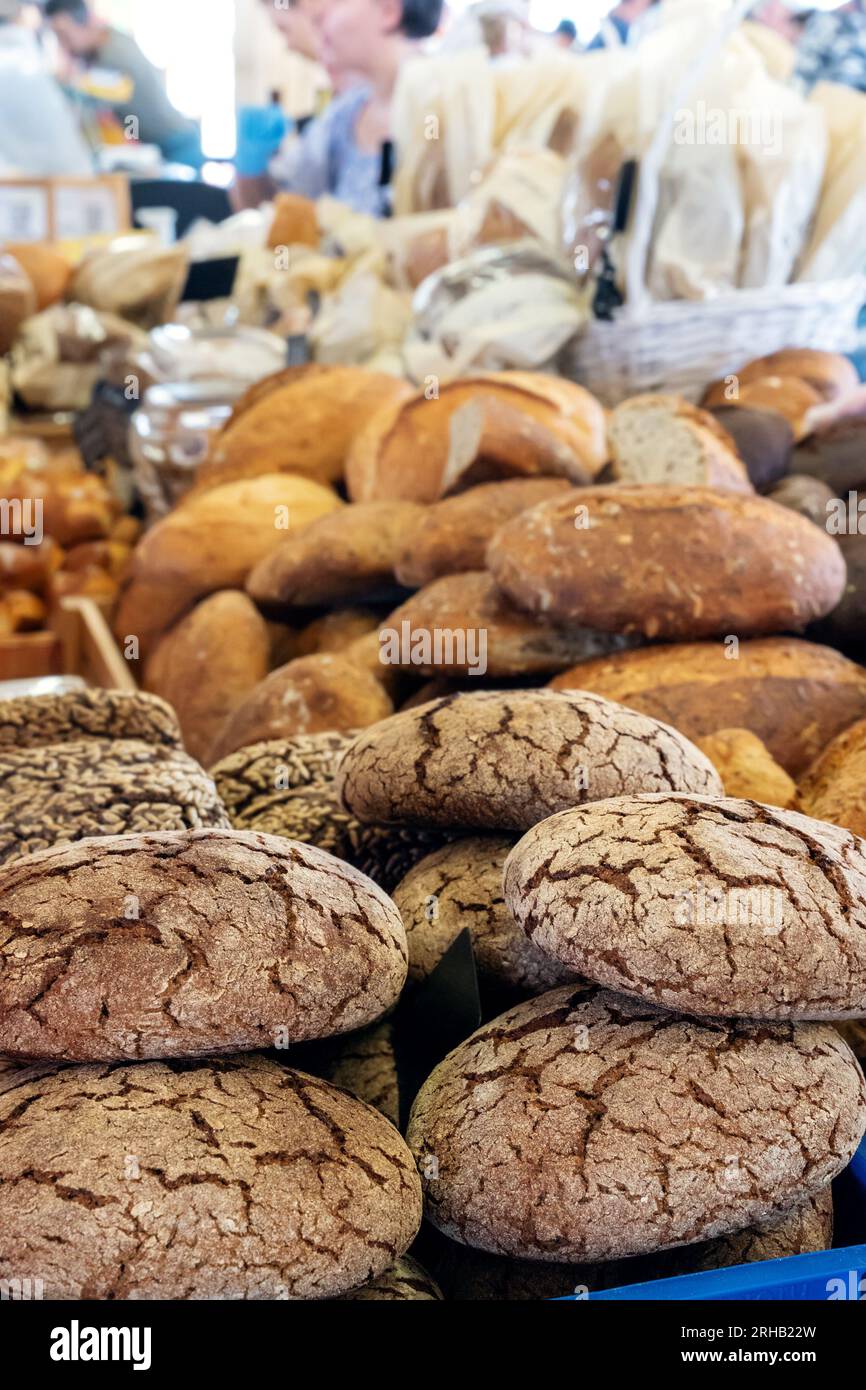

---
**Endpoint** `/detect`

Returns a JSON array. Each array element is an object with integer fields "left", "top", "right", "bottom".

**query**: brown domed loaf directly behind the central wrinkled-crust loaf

[{"left": 210, "top": 653, "right": 393, "bottom": 763}]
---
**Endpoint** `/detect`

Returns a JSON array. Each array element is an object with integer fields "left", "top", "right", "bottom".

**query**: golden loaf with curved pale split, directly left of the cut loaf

[{"left": 346, "top": 371, "right": 607, "bottom": 502}]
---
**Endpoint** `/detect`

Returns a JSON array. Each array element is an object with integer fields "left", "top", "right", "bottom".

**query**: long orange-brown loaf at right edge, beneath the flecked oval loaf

[{"left": 550, "top": 637, "right": 866, "bottom": 778}]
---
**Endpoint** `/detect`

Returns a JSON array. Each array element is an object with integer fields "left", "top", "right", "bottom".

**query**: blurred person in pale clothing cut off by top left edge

[{"left": 0, "top": 0, "right": 93, "bottom": 178}]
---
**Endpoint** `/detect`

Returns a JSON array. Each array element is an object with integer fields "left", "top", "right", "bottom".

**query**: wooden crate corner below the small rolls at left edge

[{"left": 0, "top": 598, "right": 138, "bottom": 691}]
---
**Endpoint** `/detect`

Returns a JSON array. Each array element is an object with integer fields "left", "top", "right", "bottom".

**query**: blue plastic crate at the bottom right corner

[{"left": 589, "top": 1138, "right": 866, "bottom": 1302}]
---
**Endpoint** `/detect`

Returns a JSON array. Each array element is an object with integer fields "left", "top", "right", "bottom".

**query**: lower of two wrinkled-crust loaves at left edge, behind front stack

[{"left": 0, "top": 738, "right": 231, "bottom": 865}]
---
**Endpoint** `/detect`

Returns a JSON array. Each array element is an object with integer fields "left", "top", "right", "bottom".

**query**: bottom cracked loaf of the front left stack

[{"left": 0, "top": 1056, "right": 421, "bottom": 1300}]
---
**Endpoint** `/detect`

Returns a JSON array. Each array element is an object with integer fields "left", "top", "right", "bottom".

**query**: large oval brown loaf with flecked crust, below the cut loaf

[{"left": 488, "top": 485, "right": 845, "bottom": 639}]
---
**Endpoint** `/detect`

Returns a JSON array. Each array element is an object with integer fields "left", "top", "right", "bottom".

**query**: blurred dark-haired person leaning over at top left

[{"left": 44, "top": 0, "right": 203, "bottom": 168}]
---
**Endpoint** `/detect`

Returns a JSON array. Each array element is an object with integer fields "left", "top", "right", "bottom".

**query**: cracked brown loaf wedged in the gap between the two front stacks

[{"left": 392, "top": 835, "right": 575, "bottom": 994}]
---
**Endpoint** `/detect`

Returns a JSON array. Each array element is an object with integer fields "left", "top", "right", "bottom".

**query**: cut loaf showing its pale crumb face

[{"left": 607, "top": 396, "right": 752, "bottom": 492}]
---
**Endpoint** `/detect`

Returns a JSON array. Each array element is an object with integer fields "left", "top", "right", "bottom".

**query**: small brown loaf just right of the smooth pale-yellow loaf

[{"left": 246, "top": 502, "right": 421, "bottom": 612}]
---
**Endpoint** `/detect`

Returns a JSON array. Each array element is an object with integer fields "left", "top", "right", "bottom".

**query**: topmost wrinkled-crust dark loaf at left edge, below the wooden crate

[{"left": 0, "top": 689, "right": 182, "bottom": 748}]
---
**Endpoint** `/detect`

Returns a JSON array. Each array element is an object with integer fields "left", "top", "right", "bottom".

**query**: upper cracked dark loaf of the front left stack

[{"left": 0, "top": 830, "right": 407, "bottom": 1062}]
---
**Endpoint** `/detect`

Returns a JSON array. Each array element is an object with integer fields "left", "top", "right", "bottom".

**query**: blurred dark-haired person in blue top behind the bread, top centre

[{"left": 271, "top": 0, "right": 442, "bottom": 217}]
